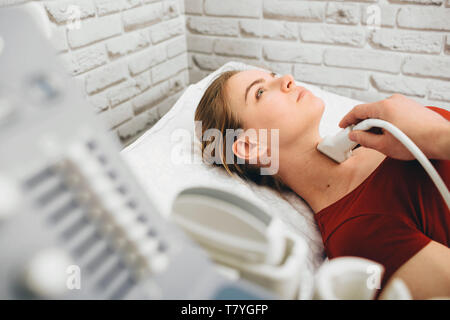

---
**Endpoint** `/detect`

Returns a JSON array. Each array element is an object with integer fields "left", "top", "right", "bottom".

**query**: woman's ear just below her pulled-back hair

[{"left": 233, "top": 132, "right": 267, "bottom": 164}]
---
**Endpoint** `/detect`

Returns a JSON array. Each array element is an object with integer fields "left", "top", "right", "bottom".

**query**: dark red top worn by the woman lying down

[{"left": 315, "top": 107, "right": 450, "bottom": 287}]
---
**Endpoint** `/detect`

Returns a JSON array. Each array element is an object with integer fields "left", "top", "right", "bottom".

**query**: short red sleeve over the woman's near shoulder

[{"left": 327, "top": 214, "right": 431, "bottom": 287}]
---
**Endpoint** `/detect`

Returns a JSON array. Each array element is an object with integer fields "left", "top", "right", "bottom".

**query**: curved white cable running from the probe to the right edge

[{"left": 352, "top": 119, "right": 450, "bottom": 209}]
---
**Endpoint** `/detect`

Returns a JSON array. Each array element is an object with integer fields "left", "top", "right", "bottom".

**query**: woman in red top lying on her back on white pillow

[{"left": 195, "top": 70, "right": 450, "bottom": 299}]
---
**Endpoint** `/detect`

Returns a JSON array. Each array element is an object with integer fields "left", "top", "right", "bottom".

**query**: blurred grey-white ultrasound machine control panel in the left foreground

[{"left": 0, "top": 9, "right": 273, "bottom": 299}]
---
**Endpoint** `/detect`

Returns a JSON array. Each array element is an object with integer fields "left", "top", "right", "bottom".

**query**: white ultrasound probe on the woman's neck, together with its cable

[{"left": 317, "top": 119, "right": 450, "bottom": 208}]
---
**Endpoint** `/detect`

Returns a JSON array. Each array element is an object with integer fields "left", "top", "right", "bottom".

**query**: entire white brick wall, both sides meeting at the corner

[{"left": 0, "top": 0, "right": 450, "bottom": 143}]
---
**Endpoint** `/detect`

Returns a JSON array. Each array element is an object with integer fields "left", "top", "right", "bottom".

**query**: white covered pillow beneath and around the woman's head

[{"left": 122, "top": 62, "right": 362, "bottom": 296}]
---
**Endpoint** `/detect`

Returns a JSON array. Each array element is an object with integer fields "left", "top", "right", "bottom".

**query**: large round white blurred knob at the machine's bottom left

[{"left": 23, "top": 248, "right": 72, "bottom": 299}]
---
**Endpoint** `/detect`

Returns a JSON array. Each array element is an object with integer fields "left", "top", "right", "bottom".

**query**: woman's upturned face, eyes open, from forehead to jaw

[{"left": 225, "top": 70, "right": 324, "bottom": 147}]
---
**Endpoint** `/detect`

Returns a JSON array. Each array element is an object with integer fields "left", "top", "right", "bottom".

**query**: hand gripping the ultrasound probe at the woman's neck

[{"left": 339, "top": 94, "right": 450, "bottom": 160}]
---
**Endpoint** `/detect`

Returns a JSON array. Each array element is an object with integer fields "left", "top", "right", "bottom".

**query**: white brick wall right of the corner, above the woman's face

[{"left": 185, "top": 0, "right": 450, "bottom": 109}]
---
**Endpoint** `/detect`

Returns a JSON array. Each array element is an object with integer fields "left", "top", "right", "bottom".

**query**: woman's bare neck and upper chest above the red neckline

[{"left": 279, "top": 136, "right": 385, "bottom": 213}]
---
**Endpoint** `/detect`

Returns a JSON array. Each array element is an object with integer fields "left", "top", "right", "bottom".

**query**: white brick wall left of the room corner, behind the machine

[{"left": 0, "top": 0, "right": 189, "bottom": 144}]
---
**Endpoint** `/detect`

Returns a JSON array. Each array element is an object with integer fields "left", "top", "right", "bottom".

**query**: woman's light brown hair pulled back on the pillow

[{"left": 195, "top": 71, "right": 290, "bottom": 192}]
